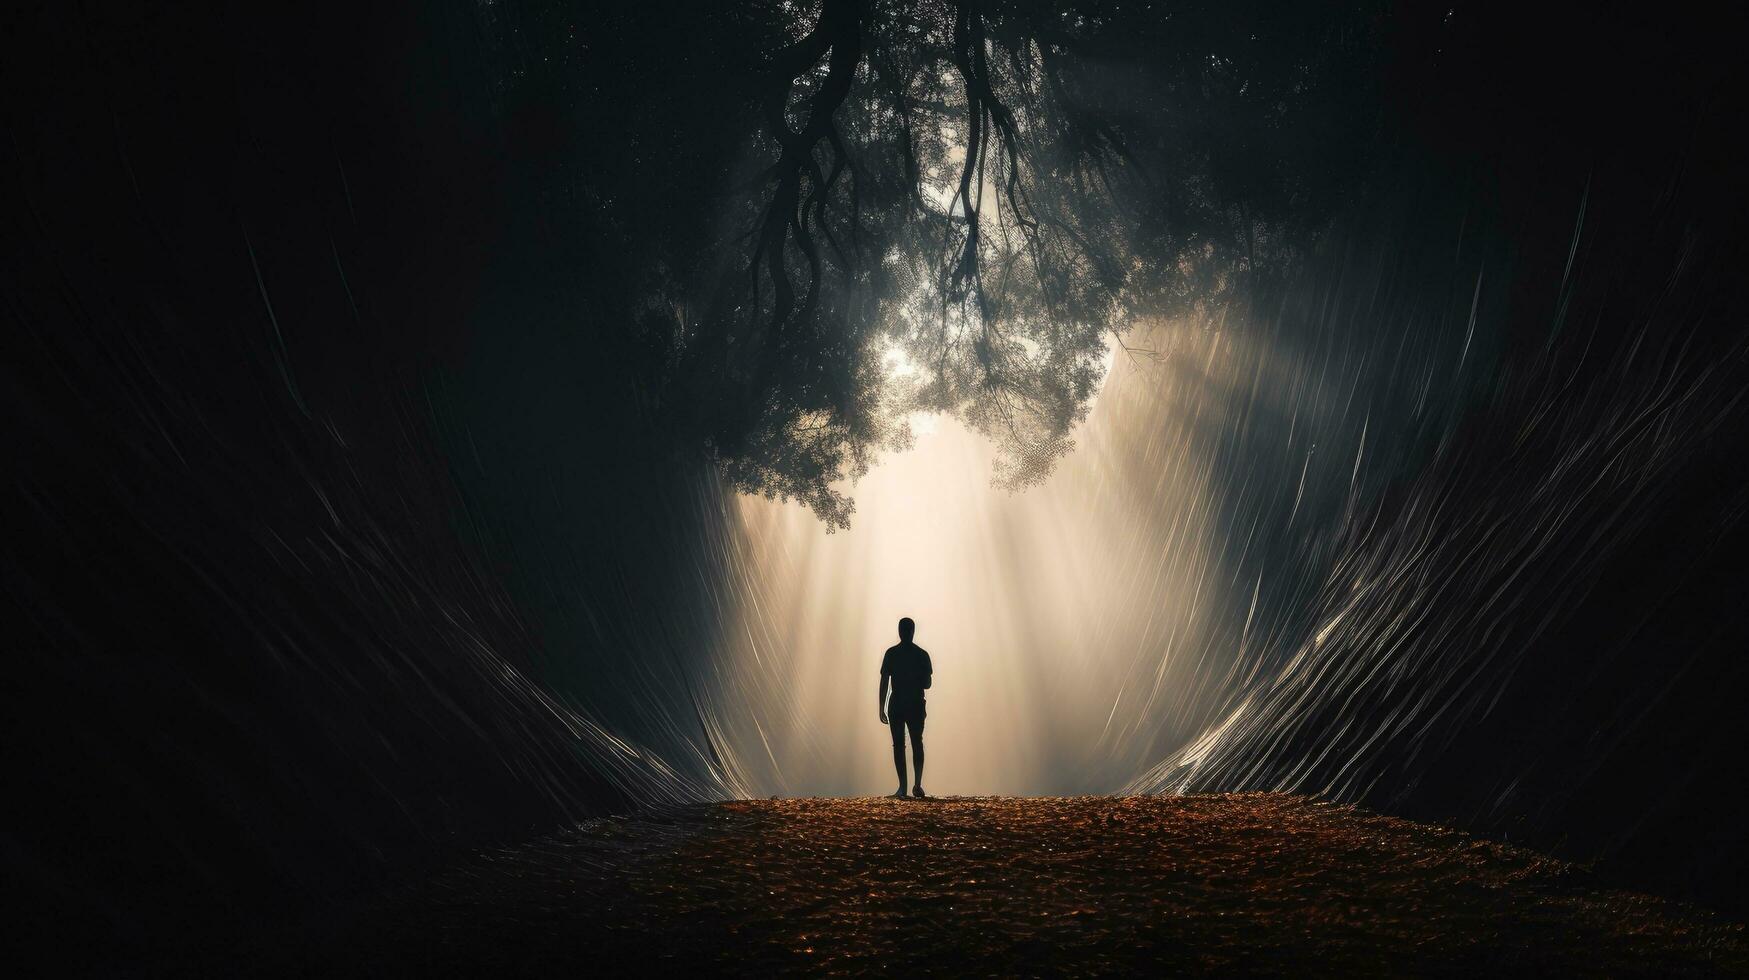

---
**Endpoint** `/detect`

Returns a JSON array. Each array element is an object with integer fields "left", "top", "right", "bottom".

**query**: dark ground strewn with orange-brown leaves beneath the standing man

[{"left": 257, "top": 795, "right": 1749, "bottom": 975}]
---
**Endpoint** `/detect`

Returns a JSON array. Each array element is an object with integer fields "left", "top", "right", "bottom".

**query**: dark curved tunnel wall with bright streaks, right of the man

[{"left": 1137, "top": 5, "right": 1749, "bottom": 910}]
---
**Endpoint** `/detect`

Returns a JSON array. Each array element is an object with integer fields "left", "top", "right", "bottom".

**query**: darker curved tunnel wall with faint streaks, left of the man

[{"left": 0, "top": 5, "right": 721, "bottom": 942}]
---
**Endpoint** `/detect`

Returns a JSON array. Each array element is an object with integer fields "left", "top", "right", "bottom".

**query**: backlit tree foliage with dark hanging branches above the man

[{"left": 512, "top": 0, "right": 1380, "bottom": 525}]
